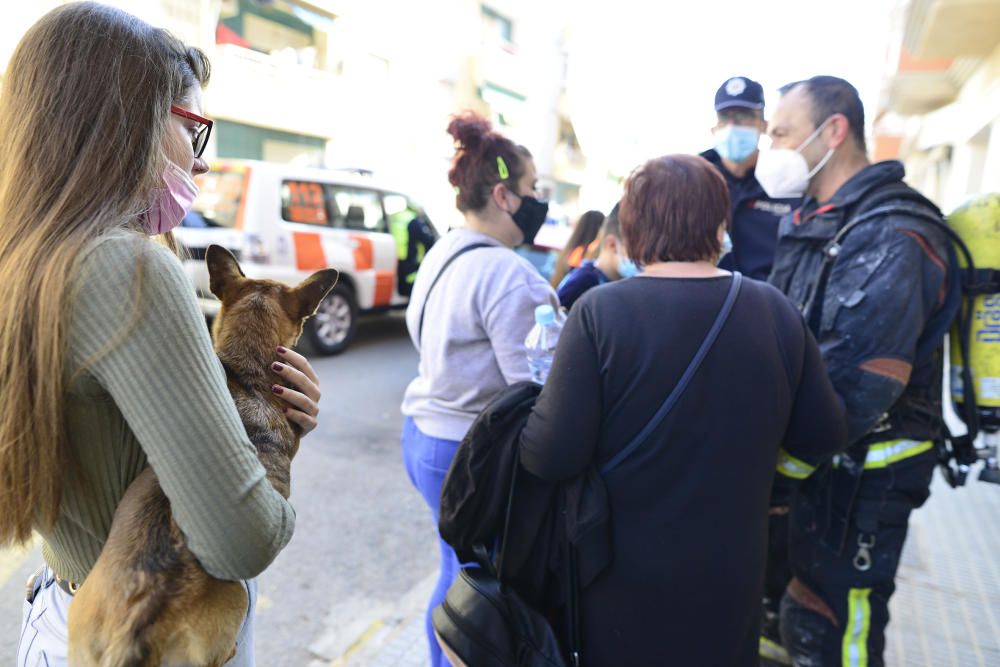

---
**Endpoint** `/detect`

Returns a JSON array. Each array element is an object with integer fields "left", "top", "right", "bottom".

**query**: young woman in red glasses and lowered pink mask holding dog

[{"left": 0, "top": 3, "right": 319, "bottom": 666}]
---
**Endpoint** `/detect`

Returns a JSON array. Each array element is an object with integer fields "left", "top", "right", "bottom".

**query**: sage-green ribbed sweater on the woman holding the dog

[{"left": 39, "top": 231, "right": 295, "bottom": 583}]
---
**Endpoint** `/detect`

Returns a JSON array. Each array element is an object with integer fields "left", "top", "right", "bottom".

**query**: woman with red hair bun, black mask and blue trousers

[{"left": 402, "top": 113, "right": 559, "bottom": 667}]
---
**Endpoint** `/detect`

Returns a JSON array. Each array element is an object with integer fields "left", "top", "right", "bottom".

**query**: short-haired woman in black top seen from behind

[{"left": 521, "top": 155, "right": 846, "bottom": 667}]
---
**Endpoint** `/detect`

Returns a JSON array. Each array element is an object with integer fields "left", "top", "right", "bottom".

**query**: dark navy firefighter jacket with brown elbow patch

[{"left": 769, "top": 161, "right": 961, "bottom": 543}]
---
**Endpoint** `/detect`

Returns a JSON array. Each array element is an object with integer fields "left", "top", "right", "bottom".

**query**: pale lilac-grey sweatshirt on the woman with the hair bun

[{"left": 402, "top": 229, "right": 559, "bottom": 440}]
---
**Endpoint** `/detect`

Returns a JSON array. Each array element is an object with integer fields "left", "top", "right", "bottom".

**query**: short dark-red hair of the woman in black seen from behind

[{"left": 618, "top": 155, "right": 732, "bottom": 265}]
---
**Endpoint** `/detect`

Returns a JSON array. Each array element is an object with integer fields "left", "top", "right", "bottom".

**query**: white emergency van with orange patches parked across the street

[{"left": 174, "top": 160, "right": 436, "bottom": 354}]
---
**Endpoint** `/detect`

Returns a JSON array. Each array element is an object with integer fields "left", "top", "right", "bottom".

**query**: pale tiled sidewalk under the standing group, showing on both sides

[{"left": 320, "top": 473, "right": 1000, "bottom": 667}]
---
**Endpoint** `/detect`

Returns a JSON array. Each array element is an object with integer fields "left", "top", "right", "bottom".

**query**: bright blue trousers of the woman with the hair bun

[{"left": 402, "top": 417, "right": 461, "bottom": 667}]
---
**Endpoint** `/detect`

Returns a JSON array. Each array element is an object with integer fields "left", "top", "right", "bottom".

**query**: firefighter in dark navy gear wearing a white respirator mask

[{"left": 756, "top": 76, "right": 960, "bottom": 666}]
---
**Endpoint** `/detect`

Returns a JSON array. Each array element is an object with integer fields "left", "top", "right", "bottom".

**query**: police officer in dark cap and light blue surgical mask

[{"left": 701, "top": 76, "right": 799, "bottom": 280}]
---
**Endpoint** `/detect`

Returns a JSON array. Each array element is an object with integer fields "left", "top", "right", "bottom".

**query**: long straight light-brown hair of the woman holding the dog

[{"left": 0, "top": 2, "right": 209, "bottom": 544}]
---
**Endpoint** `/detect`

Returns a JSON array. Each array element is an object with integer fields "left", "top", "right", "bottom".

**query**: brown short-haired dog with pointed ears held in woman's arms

[{"left": 69, "top": 246, "right": 338, "bottom": 667}]
